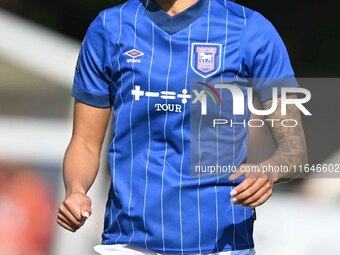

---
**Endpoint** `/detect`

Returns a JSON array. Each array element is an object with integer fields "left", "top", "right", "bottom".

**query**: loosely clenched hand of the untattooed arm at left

[{"left": 57, "top": 192, "right": 92, "bottom": 232}]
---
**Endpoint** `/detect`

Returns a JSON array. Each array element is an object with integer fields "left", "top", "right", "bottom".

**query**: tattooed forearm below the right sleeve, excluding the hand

[{"left": 263, "top": 96, "right": 308, "bottom": 181}]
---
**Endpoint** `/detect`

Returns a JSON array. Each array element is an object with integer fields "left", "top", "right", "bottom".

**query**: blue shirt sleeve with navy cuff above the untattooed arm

[{"left": 72, "top": 13, "right": 112, "bottom": 108}]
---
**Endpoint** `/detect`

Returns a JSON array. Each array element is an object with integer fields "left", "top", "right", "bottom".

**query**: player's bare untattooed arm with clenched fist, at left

[{"left": 57, "top": 101, "right": 111, "bottom": 232}]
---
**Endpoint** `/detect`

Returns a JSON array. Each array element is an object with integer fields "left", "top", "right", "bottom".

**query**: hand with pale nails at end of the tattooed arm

[{"left": 229, "top": 164, "right": 275, "bottom": 207}]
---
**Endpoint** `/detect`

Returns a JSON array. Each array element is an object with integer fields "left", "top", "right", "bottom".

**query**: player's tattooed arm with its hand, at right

[{"left": 229, "top": 95, "right": 308, "bottom": 207}]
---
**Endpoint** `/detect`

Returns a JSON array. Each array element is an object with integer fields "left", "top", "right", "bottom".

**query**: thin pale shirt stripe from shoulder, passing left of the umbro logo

[{"left": 110, "top": 3, "right": 126, "bottom": 243}]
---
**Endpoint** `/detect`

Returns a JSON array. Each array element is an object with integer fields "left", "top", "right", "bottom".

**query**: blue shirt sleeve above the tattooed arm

[{"left": 241, "top": 12, "right": 298, "bottom": 102}]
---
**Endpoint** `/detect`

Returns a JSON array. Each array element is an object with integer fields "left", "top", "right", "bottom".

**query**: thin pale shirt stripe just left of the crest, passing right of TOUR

[{"left": 179, "top": 25, "right": 191, "bottom": 254}]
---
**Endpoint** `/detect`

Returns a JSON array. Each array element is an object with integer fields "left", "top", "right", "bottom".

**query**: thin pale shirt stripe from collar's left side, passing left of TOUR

[{"left": 143, "top": 22, "right": 155, "bottom": 248}]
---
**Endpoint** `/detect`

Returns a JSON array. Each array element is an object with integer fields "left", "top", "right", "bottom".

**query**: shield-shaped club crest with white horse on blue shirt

[{"left": 191, "top": 43, "right": 222, "bottom": 78}]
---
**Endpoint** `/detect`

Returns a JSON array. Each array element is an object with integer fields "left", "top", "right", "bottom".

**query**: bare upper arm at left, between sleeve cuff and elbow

[{"left": 72, "top": 100, "right": 111, "bottom": 151}]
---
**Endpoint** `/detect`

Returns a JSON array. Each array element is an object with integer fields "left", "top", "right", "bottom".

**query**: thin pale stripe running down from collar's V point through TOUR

[{"left": 161, "top": 35, "right": 172, "bottom": 254}]
